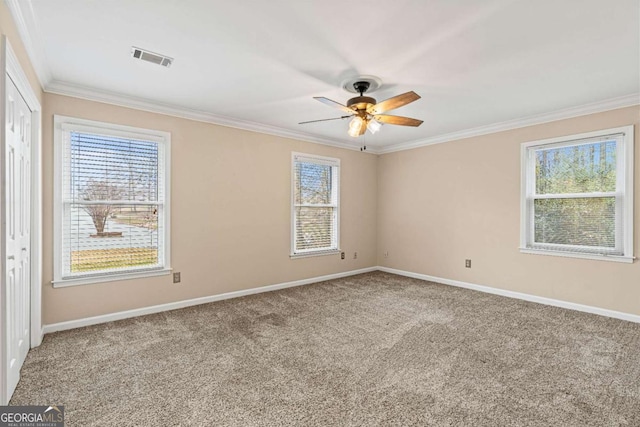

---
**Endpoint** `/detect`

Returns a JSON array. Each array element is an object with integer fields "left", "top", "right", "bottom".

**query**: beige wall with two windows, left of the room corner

[{"left": 43, "top": 93, "right": 378, "bottom": 324}]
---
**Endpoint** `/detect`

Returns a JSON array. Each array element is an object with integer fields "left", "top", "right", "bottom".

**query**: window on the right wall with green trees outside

[{"left": 521, "top": 126, "right": 633, "bottom": 262}]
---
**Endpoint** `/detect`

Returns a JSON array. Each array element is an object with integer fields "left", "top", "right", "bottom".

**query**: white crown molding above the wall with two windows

[{"left": 44, "top": 80, "right": 377, "bottom": 154}]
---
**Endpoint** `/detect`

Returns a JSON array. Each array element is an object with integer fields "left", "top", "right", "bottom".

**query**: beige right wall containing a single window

[{"left": 378, "top": 107, "right": 640, "bottom": 315}]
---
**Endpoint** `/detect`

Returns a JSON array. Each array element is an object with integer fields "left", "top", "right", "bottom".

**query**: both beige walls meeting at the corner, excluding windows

[{"left": 36, "top": 98, "right": 640, "bottom": 324}]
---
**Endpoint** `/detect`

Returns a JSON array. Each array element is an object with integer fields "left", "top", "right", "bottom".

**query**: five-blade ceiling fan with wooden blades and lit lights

[{"left": 299, "top": 81, "right": 422, "bottom": 137}]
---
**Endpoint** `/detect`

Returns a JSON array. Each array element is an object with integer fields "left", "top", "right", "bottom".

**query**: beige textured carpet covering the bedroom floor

[{"left": 11, "top": 272, "right": 640, "bottom": 426}]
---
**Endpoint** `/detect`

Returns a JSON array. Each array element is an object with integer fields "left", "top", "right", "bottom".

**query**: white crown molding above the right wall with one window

[{"left": 377, "top": 93, "right": 640, "bottom": 154}]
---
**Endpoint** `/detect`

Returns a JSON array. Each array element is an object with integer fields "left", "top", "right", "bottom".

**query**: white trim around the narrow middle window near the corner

[{"left": 289, "top": 152, "right": 341, "bottom": 259}]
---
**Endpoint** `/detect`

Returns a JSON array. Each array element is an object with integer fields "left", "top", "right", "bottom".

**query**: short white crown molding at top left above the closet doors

[{"left": 5, "top": 0, "right": 52, "bottom": 89}]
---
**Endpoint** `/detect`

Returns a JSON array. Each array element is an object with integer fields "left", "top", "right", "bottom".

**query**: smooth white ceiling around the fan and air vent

[{"left": 9, "top": 0, "right": 640, "bottom": 152}]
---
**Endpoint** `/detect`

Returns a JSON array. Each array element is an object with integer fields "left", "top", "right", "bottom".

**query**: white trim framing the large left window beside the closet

[{"left": 51, "top": 114, "right": 173, "bottom": 288}]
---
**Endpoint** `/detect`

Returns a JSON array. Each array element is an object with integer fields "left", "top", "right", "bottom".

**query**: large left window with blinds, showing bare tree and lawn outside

[{"left": 53, "top": 116, "right": 171, "bottom": 286}]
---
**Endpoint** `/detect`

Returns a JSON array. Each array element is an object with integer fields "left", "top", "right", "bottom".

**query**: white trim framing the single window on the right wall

[{"left": 519, "top": 125, "right": 635, "bottom": 263}]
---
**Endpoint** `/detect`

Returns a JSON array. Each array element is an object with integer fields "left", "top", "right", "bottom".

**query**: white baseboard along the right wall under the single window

[{"left": 378, "top": 267, "right": 640, "bottom": 323}]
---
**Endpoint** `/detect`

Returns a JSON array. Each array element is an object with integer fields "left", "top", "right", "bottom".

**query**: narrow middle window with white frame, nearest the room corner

[{"left": 291, "top": 153, "right": 340, "bottom": 257}]
